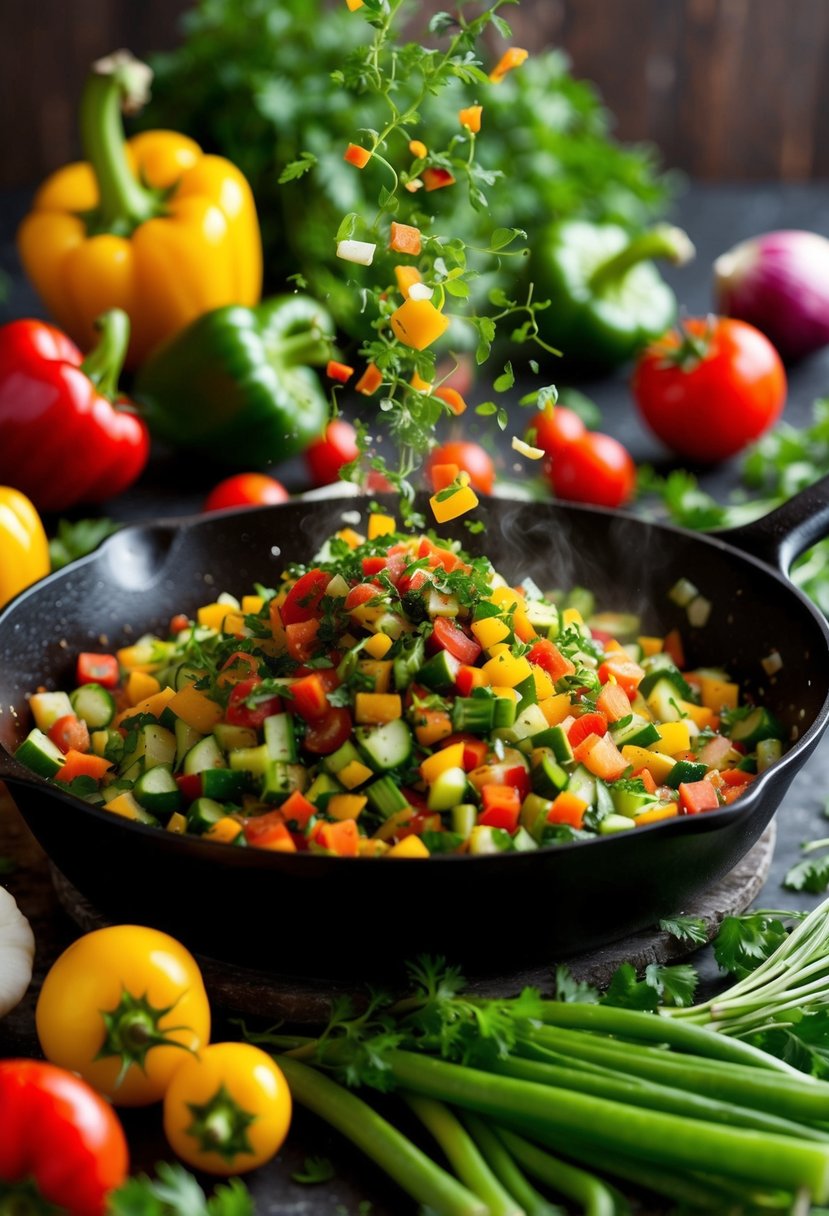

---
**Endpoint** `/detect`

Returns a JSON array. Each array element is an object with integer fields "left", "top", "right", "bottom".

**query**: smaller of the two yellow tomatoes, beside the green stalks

[{"left": 164, "top": 1043, "right": 291, "bottom": 1175}]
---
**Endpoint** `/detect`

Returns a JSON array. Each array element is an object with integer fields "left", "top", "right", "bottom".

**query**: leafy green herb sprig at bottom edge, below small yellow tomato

[{"left": 107, "top": 1161, "right": 254, "bottom": 1216}]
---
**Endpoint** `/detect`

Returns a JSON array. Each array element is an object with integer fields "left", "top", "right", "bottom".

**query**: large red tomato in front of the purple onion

[{"left": 632, "top": 317, "right": 786, "bottom": 463}]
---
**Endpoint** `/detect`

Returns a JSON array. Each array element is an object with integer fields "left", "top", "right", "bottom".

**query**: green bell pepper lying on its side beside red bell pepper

[{"left": 134, "top": 295, "right": 334, "bottom": 469}]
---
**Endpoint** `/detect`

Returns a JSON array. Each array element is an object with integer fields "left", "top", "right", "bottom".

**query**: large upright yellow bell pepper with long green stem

[{"left": 17, "top": 51, "right": 261, "bottom": 367}]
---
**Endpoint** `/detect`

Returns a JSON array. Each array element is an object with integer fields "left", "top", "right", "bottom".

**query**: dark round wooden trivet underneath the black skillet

[{"left": 52, "top": 822, "right": 777, "bottom": 1025}]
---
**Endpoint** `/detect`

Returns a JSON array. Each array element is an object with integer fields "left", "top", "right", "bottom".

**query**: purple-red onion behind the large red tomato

[{"left": 714, "top": 230, "right": 829, "bottom": 360}]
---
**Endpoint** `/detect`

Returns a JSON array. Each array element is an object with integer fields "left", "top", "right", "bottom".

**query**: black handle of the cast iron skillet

[{"left": 711, "top": 477, "right": 829, "bottom": 575}]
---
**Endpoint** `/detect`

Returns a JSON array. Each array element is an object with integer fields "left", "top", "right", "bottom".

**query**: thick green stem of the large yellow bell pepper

[{"left": 80, "top": 51, "right": 158, "bottom": 236}]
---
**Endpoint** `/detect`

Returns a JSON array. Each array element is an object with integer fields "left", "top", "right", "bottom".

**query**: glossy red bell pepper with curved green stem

[{"left": 0, "top": 309, "right": 150, "bottom": 511}]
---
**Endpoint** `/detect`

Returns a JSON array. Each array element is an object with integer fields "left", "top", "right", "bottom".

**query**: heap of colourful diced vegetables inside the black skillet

[{"left": 16, "top": 514, "right": 783, "bottom": 857}]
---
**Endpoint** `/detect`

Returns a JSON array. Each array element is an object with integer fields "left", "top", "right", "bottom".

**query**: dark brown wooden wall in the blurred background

[{"left": 0, "top": 0, "right": 829, "bottom": 187}]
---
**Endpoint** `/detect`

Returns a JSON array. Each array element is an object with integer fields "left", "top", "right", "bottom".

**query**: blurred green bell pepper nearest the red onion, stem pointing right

[{"left": 531, "top": 220, "right": 694, "bottom": 367}]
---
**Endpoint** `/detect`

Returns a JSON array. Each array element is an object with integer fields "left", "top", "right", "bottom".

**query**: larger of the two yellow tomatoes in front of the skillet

[{"left": 35, "top": 924, "right": 210, "bottom": 1107}]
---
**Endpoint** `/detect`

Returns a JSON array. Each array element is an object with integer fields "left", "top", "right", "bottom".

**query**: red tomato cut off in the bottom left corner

[{"left": 0, "top": 1059, "right": 128, "bottom": 1216}]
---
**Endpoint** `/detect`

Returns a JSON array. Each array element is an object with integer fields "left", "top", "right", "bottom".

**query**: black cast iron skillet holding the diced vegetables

[{"left": 0, "top": 478, "right": 829, "bottom": 976}]
